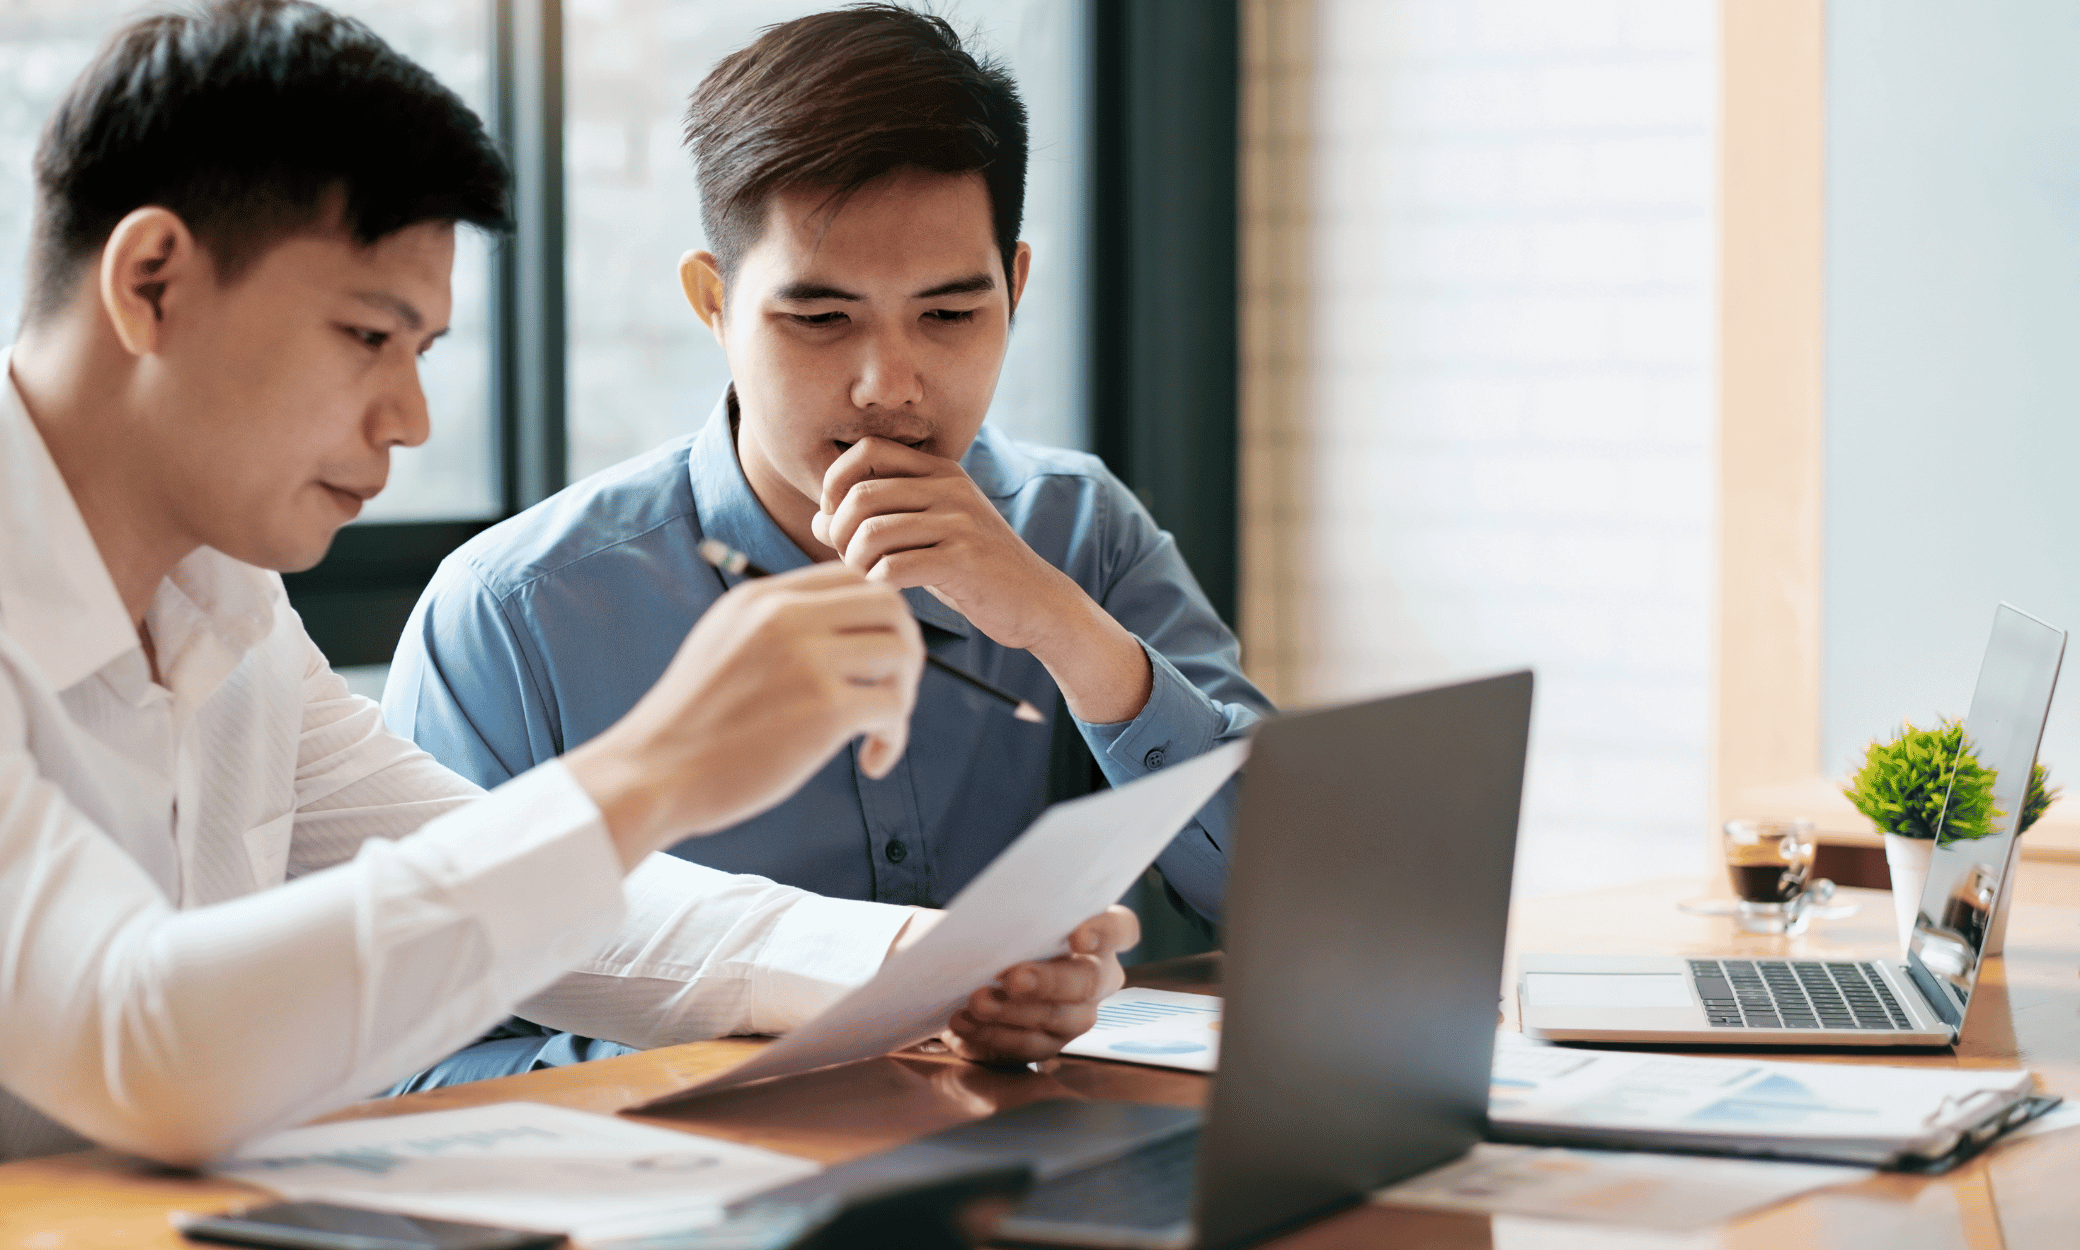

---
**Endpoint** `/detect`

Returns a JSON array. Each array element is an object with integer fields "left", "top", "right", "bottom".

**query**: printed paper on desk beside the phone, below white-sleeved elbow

[{"left": 212, "top": 1102, "right": 820, "bottom": 1242}]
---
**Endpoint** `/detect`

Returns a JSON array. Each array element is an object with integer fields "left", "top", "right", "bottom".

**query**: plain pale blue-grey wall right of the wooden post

[{"left": 1822, "top": 0, "right": 2080, "bottom": 774}]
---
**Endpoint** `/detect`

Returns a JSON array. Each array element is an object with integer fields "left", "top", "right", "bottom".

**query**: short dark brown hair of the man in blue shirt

[{"left": 686, "top": 4, "right": 1028, "bottom": 281}]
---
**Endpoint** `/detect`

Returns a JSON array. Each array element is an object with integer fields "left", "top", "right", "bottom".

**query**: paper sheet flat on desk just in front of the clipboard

[{"left": 1373, "top": 1142, "right": 1872, "bottom": 1231}]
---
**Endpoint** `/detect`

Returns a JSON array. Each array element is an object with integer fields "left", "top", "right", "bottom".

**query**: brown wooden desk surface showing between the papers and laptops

[{"left": 0, "top": 863, "right": 2080, "bottom": 1250}]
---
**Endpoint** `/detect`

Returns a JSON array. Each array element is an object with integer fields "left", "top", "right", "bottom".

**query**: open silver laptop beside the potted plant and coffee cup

[{"left": 1516, "top": 603, "right": 2065, "bottom": 1048}]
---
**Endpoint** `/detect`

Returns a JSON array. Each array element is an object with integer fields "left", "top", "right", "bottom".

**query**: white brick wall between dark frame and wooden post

[{"left": 1294, "top": 0, "right": 1716, "bottom": 892}]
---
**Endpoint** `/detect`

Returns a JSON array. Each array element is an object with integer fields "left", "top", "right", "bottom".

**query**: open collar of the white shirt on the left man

[{"left": 0, "top": 349, "right": 275, "bottom": 703}]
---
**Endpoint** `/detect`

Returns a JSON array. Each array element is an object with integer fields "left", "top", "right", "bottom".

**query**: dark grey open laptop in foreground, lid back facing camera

[{"left": 996, "top": 672, "right": 1531, "bottom": 1248}]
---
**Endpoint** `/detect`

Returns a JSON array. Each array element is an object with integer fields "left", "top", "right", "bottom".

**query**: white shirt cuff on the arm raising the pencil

[{"left": 393, "top": 759, "right": 626, "bottom": 998}]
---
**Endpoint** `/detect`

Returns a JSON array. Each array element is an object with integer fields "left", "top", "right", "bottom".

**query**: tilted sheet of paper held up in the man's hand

[{"left": 628, "top": 743, "right": 1250, "bottom": 1111}]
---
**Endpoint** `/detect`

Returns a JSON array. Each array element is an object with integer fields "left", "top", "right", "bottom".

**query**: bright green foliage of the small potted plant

[{"left": 1843, "top": 718, "right": 2059, "bottom": 842}]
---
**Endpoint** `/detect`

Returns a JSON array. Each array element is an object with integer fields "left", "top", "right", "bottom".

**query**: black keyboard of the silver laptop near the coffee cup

[{"left": 1689, "top": 959, "right": 1907, "bottom": 1030}]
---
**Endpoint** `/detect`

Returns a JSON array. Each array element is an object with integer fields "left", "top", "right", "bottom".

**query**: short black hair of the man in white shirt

[{"left": 27, "top": 0, "right": 512, "bottom": 320}]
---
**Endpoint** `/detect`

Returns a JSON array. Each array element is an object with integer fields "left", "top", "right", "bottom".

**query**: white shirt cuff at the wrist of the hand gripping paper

[{"left": 751, "top": 892, "right": 915, "bottom": 1034}]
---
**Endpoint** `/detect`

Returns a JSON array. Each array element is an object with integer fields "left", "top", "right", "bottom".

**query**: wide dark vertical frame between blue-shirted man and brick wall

[{"left": 1090, "top": 0, "right": 1242, "bottom": 622}]
